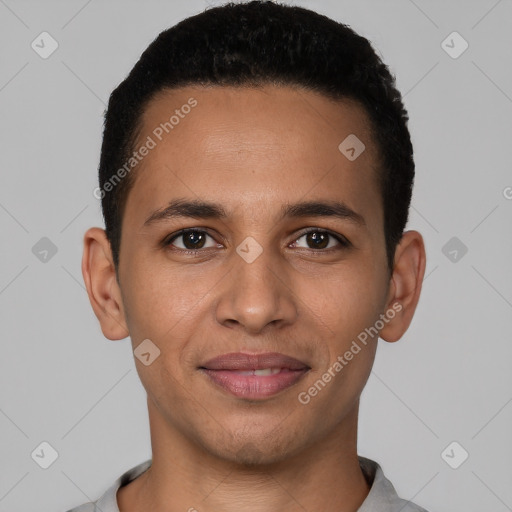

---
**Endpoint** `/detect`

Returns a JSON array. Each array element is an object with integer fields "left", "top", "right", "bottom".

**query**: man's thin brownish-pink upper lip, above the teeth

[{"left": 200, "top": 352, "right": 309, "bottom": 370}]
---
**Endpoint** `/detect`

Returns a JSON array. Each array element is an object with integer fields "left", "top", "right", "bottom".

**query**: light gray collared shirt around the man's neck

[{"left": 67, "top": 457, "right": 427, "bottom": 512}]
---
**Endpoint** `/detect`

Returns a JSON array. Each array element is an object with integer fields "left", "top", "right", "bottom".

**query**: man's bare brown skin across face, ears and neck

[{"left": 82, "top": 85, "right": 425, "bottom": 512}]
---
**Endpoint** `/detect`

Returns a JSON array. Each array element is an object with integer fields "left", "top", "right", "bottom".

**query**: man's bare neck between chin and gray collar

[{"left": 117, "top": 400, "right": 369, "bottom": 512}]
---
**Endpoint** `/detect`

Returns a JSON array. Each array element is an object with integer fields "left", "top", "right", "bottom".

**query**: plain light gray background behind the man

[{"left": 0, "top": 0, "right": 512, "bottom": 512}]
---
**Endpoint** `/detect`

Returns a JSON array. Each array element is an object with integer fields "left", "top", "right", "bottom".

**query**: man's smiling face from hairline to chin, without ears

[{"left": 114, "top": 86, "right": 390, "bottom": 463}]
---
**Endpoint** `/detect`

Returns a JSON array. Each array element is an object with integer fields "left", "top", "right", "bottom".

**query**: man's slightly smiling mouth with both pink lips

[{"left": 198, "top": 352, "right": 311, "bottom": 400}]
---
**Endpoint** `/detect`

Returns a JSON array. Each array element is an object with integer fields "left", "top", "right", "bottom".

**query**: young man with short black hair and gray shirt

[{"left": 69, "top": 1, "right": 425, "bottom": 512}]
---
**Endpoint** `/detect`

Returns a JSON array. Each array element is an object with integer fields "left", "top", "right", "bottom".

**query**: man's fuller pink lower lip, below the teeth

[{"left": 201, "top": 368, "right": 308, "bottom": 399}]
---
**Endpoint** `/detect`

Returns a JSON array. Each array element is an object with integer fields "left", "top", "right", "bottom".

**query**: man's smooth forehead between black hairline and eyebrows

[{"left": 126, "top": 85, "right": 381, "bottom": 228}]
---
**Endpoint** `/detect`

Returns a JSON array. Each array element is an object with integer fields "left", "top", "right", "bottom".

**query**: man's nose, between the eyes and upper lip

[{"left": 216, "top": 246, "right": 298, "bottom": 334}]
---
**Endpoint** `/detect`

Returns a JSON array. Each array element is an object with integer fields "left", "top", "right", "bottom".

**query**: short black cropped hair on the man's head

[{"left": 99, "top": 0, "right": 414, "bottom": 272}]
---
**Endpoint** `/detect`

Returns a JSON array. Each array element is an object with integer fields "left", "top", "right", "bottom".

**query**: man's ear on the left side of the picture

[{"left": 82, "top": 228, "right": 129, "bottom": 340}]
